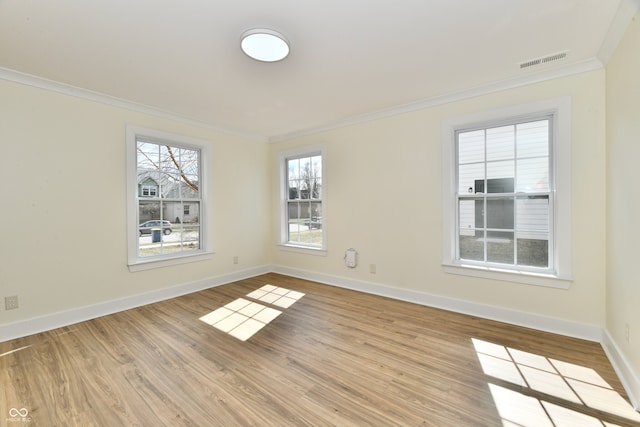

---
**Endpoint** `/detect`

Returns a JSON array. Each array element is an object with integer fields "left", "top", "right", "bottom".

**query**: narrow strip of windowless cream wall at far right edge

[{"left": 606, "top": 9, "right": 640, "bottom": 401}]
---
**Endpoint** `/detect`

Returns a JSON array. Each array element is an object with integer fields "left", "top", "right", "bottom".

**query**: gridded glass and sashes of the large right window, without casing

[{"left": 455, "top": 115, "right": 554, "bottom": 273}]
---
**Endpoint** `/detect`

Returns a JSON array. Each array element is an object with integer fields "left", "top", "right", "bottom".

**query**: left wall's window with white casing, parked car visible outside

[{"left": 127, "top": 127, "right": 208, "bottom": 266}]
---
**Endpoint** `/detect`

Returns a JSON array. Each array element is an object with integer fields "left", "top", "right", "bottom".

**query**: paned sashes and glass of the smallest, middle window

[{"left": 282, "top": 151, "right": 325, "bottom": 249}]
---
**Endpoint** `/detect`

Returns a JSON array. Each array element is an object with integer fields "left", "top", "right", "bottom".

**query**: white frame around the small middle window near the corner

[{"left": 278, "top": 145, "right": 327, "bottom": 256}]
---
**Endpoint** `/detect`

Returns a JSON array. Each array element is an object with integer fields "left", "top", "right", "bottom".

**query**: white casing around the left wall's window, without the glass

[{"left": 126, "top": 125, "right": 213, "bottom": 272}]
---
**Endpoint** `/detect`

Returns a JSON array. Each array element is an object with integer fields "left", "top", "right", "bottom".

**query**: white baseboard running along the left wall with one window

[{"left": 0, "top": 266, "right": 271, "bottom": 342}]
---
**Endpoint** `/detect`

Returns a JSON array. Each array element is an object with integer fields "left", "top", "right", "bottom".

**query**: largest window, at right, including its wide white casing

[{"left": 443, "top": 98, "right": 571, "bottom": 287}]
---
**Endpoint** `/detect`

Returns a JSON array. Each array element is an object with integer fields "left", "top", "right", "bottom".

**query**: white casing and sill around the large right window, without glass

[{"left": 442, "top": 97, "right": 572, "bottom": 289}]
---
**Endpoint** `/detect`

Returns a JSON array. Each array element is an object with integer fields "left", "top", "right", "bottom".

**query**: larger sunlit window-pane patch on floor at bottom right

[{"left": 472, "top": 338, "right": 640, "bottom": 427}]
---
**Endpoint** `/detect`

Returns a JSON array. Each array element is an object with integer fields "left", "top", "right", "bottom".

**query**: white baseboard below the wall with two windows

[{"left": 272, "top": 265, "right": 602, "bottom": 342}]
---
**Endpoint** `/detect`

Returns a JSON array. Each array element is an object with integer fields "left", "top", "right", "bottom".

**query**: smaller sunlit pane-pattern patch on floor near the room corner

[{"left": 200, "top": 285, "right": 304, "bottom": 341}]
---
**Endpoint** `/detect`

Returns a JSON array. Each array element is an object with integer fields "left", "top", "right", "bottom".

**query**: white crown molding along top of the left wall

[{"left": 0, "top": 67, "right": 268, "bottom": 142}]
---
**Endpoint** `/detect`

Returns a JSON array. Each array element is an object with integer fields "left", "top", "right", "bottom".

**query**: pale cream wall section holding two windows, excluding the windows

[{"left": 271, "top": 70, "right": 606, "bottom": 328}]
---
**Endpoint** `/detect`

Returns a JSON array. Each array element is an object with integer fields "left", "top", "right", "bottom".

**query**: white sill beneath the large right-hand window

[{"left": 443, "top": 264, "right": 573, "bottom": 289}]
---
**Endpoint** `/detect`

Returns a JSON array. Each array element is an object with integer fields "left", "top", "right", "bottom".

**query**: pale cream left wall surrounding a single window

[{"left": 0, "top": 80, "right": 270, "bottom": 328}]
